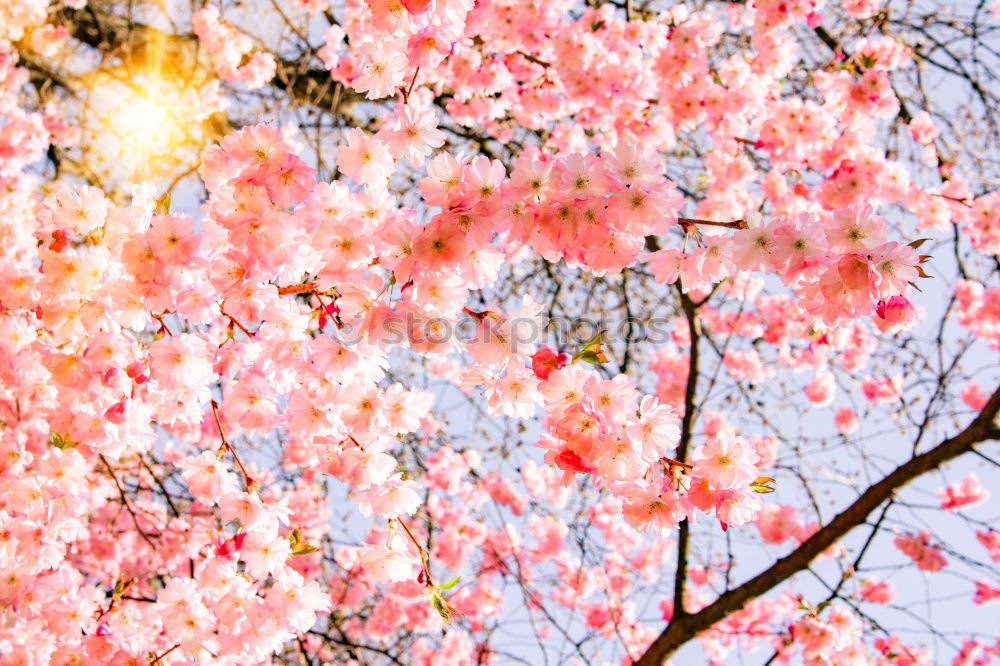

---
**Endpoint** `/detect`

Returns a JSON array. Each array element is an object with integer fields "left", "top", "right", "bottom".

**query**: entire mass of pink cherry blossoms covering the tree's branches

[{"left": 0, "top": 0, "right": 1000, "bottom": 664}]
